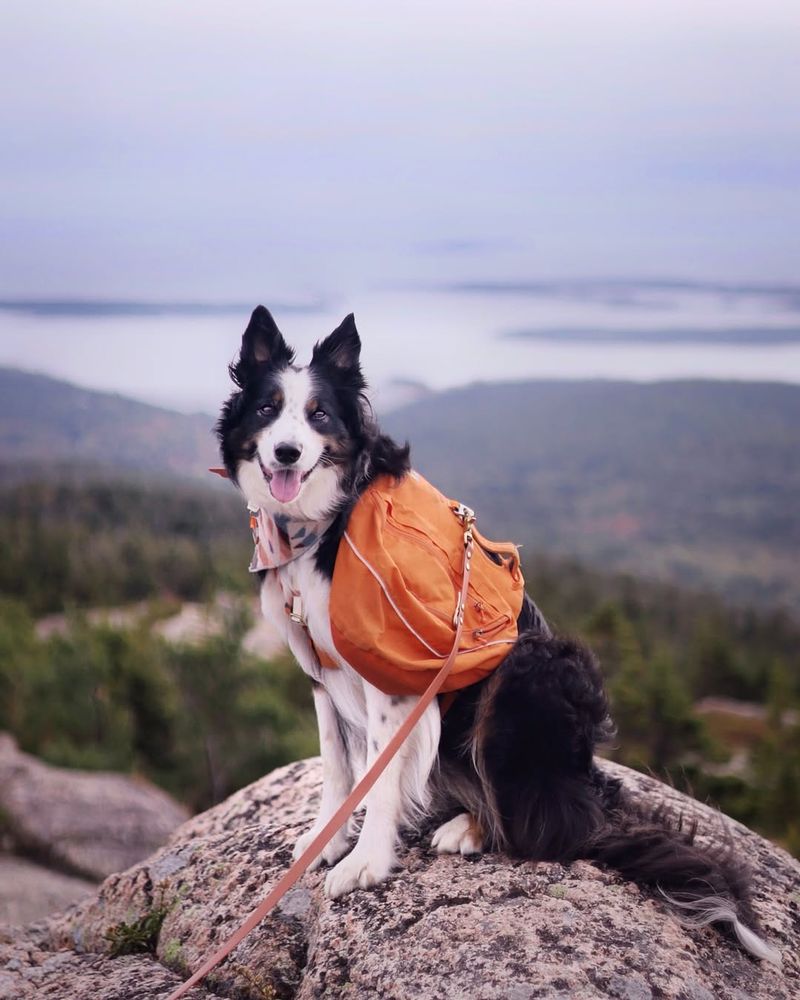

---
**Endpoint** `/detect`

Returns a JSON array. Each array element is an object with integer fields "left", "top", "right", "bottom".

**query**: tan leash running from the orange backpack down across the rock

[{"left": 167, "top": 505, "right": 475, "bottom": 1000}]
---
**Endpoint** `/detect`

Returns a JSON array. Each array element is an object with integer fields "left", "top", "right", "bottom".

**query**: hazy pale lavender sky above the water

[{"left": 0, "top": 0, "right": 800, "bottom": 301}]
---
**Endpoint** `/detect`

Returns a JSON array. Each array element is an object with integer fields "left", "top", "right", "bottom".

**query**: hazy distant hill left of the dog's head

[{"left": 0, "top": 367, "right": 218, "bottom": 478}]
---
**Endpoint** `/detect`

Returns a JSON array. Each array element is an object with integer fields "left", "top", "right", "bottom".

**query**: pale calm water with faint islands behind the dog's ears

[{"left": 0, "top": 286, "right": 800, "bottom": 412}]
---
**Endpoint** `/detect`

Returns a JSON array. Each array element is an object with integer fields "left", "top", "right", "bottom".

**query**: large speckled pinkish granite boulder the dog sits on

[{"left": 0, "top": 761, "right": 800, "bottom": 1000}]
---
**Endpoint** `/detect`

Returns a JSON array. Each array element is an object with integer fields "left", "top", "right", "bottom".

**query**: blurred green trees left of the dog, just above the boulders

[{"left": 0, "top": 598, "right": 317, "bottom": 810}]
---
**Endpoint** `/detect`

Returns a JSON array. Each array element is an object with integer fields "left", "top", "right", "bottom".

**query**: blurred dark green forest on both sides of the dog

[{"left": 0, "top": 468, "right": 800, "bottom": 853}]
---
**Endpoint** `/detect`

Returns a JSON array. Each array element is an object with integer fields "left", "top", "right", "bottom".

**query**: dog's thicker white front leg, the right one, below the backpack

[{"left": 325, "top": 684, "right": 440, "bottom": 899}]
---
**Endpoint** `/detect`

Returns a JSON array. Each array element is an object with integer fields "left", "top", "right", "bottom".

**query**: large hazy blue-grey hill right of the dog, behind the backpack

[{"left": 384, "top": 381, "right": 800, "bottom": 609}]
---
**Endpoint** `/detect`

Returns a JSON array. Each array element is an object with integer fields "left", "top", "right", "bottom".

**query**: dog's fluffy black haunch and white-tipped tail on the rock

[{"left": 473, "top": 633, "right": 780, "bottom": 962}]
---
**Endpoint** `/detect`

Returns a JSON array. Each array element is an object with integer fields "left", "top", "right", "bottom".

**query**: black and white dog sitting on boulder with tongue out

[{"left": 216, "top": 306, "right": 777, "bottom": 961}]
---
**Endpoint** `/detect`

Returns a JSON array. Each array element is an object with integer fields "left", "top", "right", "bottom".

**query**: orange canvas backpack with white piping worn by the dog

[{"left": 330, "top": 472, "right": 524, "bottom": 695}]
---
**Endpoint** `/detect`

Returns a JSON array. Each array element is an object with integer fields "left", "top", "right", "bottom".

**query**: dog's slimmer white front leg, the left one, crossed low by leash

[{"left": 293, "top": 682, "right": 353, "bottom": 871}]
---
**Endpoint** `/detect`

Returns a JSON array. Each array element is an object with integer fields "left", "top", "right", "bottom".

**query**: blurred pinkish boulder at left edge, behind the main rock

[{"left": 0, "top": 733, "right": 189, "bottom": 879}]
